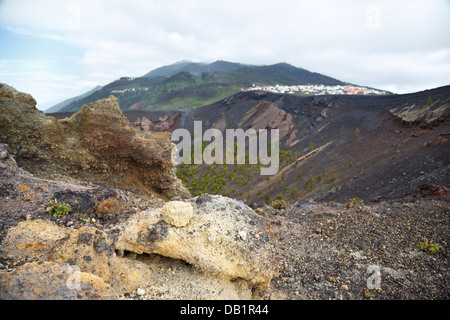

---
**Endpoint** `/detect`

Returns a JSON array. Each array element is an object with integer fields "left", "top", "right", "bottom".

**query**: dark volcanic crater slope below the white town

[{"left": 74, "top": 86, "right": 450, "bottom": 204}]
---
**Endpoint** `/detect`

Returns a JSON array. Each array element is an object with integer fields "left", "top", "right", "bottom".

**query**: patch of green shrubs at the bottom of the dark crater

[{"left": 176, "top": 142, "right": 338, "bottom": 205}]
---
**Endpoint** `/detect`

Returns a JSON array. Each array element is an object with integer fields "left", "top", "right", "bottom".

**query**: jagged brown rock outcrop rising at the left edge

[{"left": 0, "top": 84, "right": 189, "bottom": 198}]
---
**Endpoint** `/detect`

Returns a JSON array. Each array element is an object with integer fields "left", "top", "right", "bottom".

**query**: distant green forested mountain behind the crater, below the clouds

[{"left": 48, "top": 61, "right": 352, "bottom": 112}]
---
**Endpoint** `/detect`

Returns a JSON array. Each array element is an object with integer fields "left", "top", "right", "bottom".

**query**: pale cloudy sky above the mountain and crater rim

[{"left": 0, "top": 0, "right": 450, "bottom": 110}]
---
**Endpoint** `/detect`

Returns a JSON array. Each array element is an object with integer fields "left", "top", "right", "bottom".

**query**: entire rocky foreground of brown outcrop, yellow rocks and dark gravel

[{"left": 0, "top": 87, "right": 450, "bottom": 300}]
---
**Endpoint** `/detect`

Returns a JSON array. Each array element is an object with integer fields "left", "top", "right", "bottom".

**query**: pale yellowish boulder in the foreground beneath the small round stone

[{"left": 115, "top": 195, "right": 277, "bottom": 289}]
